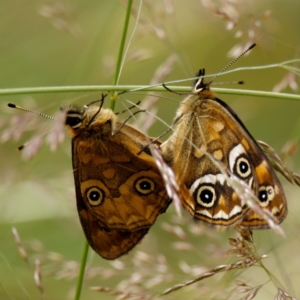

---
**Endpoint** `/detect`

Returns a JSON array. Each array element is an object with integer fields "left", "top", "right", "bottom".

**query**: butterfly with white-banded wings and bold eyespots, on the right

[{"left": 161, "top": 69, "right": 287, "bottom": 229}]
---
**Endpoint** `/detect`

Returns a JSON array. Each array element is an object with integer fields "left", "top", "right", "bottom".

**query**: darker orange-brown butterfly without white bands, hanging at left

[{"left": 65, "top": 97, "right": 170, "bottom": 259}]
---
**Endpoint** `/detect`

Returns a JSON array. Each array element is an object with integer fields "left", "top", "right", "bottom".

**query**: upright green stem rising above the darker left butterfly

[{"left": 110, "top": 0, "right": 132, "bottom": 110}]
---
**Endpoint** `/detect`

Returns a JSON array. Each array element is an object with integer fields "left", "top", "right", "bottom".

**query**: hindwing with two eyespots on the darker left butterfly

[{"left": 73, "top": 125, "right": 170, "bottom": 231}]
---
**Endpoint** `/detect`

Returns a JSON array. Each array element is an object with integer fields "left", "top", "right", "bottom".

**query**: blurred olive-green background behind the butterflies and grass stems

[{"left": 0, "top": 0, "right": 300, "bottom": 299}]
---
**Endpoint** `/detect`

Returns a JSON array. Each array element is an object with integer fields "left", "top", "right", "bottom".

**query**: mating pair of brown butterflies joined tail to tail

[{"left": 62, "top": 70, "right": 287, "bottom": 259}]
